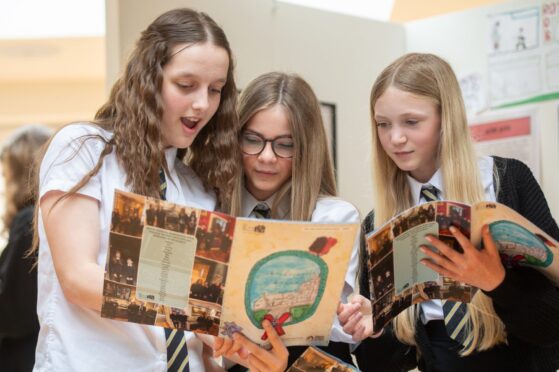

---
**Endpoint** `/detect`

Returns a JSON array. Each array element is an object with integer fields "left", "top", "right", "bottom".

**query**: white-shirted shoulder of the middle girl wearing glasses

[{"left": 311, "top": 196, "right": 360, "bottom": 223}]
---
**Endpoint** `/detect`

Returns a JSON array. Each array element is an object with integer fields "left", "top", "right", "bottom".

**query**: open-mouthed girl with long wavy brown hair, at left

[{"left": 35, "top": 9, "right": 242, "bottom": 371}]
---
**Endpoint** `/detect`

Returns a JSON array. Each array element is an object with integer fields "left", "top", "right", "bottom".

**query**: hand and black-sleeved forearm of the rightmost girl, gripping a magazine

[{"left": 421, "top": 225, "right": 559, "bottom": 346}]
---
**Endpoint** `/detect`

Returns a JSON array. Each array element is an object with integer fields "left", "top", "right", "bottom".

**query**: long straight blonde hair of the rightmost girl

[{"left": 370, "top": 53, "right": 506, "bottom": 355}]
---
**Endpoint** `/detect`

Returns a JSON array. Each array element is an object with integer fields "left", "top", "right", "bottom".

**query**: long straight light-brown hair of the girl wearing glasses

[{"left": 230, "top": 72, "right": 336, "bottom": 221}]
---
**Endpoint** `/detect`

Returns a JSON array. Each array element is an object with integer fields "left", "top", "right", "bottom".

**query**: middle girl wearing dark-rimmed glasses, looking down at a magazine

[{"left": 215, "top": 72, "right": 359, "bottom": 371}]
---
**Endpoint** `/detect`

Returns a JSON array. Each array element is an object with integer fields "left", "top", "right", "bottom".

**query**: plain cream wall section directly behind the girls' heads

[{"left": 107, "top": 0, "right": 405, "bottom": 213}]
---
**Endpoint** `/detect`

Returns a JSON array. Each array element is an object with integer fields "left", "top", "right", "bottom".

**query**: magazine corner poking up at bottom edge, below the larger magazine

[{"left": 287, "top": 346, "right": 359, "bottom": 372}]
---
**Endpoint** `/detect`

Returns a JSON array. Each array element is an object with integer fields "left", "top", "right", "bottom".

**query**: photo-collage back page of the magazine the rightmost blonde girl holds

[{"left": 367, "top": 201, "right": 472, "bottom": 332}]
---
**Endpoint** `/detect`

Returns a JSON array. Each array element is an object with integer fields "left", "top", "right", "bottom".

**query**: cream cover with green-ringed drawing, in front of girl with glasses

[{"left": 222, "top": 218, "right": 359, "bottom": 346}]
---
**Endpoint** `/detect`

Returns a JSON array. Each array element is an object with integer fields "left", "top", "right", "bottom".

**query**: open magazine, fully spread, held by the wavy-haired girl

[{"left": 101, "top": 190, "right": 359, "bottom": 345}]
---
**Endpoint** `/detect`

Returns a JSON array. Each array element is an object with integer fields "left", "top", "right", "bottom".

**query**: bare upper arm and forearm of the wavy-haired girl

[{"left": 40, "top": 191, "right": 104, "bottom": 311}]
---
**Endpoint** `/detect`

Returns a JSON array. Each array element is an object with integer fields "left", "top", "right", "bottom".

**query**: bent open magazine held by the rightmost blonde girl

[{"left": 367, "top": 201, "right": 559, "bottom": 332}]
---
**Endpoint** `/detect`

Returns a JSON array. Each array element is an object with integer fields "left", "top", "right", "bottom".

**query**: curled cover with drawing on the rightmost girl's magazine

[{"left": 472, "top": 202, "right": 559, "bottom": 285}]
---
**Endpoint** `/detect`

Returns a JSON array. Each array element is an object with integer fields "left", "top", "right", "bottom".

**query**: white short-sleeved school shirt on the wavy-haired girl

[{"left": 34, "top": 124, "right": 215, "bottom": 372}]
